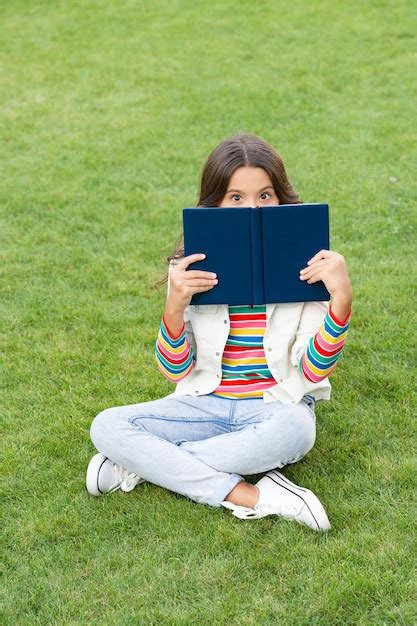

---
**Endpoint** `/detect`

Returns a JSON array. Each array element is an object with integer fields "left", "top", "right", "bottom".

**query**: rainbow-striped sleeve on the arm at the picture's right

[{"left": 299, "top": 305, "right": 352, "bottom": 383}]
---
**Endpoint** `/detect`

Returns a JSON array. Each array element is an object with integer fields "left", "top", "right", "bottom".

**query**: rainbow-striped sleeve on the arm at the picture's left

[{"left": 155, "top": 318, "right": 194, "bottom": 383}]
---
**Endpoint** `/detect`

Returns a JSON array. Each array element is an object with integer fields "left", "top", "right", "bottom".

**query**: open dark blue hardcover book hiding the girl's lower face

[{"left": 183, "top": 204, "right": 330, "bottom": 305}]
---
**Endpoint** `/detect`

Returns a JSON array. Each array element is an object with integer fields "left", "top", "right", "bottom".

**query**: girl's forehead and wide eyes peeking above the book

[{"left": 219, "top": 167, "right": 279, "bottom": 207}]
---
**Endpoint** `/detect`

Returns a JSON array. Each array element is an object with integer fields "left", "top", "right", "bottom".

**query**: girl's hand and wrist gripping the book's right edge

[{"left": 300, "top": 250, "right": 352, "bottom": 317}]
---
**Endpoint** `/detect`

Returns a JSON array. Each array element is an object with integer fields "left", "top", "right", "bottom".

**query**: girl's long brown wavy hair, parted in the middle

[{"left": 156, "top": 134, "right": 301, "bottom": 286}]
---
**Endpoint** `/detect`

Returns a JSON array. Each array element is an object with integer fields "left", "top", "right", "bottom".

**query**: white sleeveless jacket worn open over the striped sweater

[{"left": 173, "top": 302, "right": 331, "bottom": 404}]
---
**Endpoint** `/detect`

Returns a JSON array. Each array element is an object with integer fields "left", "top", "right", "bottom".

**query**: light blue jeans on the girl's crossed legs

[{"left": 91, "top": 394, "right": 316, "bottom": 506}]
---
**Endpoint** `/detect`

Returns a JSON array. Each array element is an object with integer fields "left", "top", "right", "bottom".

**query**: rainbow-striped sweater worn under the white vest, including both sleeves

[{"left": 155, "top": 305, "right": 350, "bottom": 399}]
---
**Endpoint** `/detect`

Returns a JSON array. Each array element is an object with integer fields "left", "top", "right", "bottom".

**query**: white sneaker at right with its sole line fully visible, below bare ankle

[{"left": 221, "top": 470, "right": 330, "bottom": 531}]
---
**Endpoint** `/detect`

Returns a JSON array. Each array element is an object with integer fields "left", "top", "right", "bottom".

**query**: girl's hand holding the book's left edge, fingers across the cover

[{"left": 167, "top": 254, "right": 219, "bottom": 311}]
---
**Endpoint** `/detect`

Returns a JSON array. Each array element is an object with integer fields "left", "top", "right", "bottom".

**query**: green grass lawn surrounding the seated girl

[{"left": 0, "top": 0, "right": 417, "bottom": 626}]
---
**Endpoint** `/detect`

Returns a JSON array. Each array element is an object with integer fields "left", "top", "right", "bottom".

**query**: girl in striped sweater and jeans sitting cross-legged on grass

[{"left": 87, "top": 135, "right": 352, "bottom": 531}]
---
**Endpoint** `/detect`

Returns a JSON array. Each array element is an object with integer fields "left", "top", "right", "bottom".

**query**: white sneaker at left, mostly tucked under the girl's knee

[{"left": 86, "top": 453, "right": 145, "bottom": 496}]
